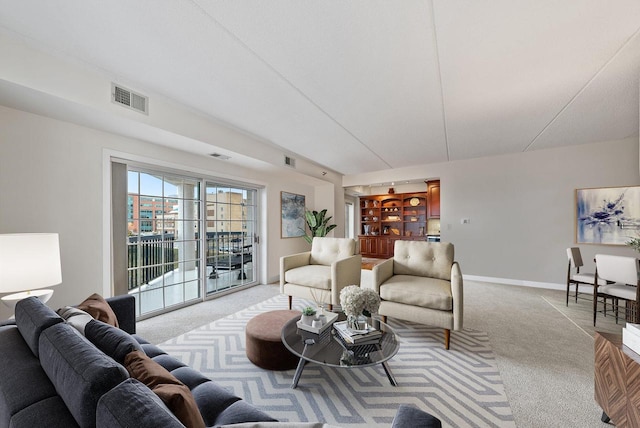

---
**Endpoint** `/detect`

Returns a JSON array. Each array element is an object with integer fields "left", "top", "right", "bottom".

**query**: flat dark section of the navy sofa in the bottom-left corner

[{"left": 0, "top": 326, "right": 66, "bottom": 427}]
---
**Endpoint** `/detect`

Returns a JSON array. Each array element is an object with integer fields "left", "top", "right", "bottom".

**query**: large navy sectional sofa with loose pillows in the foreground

[{"left": 0, "top": 296, "right": 440, "bottom": 428}]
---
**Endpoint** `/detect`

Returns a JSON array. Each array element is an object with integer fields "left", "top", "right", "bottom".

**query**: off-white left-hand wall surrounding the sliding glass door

[{"left": 0, "top": 106, "right": 344, "bottom": 318}]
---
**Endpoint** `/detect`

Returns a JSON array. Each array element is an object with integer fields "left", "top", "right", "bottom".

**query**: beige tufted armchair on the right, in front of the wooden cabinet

[{"left": 372, "top": 240, "right": 464, "bottom": 349}]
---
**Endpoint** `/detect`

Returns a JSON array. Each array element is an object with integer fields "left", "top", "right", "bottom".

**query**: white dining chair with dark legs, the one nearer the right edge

[{"left": 593, "top": 254, "right": 640, "bottom": 326}]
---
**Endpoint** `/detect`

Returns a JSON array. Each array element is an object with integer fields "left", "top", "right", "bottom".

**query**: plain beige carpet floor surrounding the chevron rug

[{"left": 138, "top": 281, "right": 623, "bottom": 428}]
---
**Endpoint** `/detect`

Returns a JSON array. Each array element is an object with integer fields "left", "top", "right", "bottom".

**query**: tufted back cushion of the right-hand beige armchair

[{"left": 393, "top": 240, "right": 454, "bottom": 281}]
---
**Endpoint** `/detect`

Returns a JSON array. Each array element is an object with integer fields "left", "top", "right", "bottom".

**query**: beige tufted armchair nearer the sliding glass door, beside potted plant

[{"left": 280, "top": 237, "right": 362, "bottom": 310}]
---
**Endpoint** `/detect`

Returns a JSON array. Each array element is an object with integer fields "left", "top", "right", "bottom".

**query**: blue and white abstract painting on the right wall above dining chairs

[{"left": 576, "top": 186, "right": 640, "bottom": 245}]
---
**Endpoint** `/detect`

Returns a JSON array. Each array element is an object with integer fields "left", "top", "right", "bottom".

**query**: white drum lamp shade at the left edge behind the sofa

[{"left": 0, "top": 233, "right": 62, "bottom": 293}]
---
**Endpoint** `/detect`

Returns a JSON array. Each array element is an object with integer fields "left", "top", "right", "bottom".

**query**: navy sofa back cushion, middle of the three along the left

[{"left": 40, "top": 323, "right": 128, "bottom": 427}]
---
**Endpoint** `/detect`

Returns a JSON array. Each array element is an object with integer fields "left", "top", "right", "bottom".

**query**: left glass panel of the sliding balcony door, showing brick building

[{"left": 127, "top": 169, "right": 202, "bottom": 316}]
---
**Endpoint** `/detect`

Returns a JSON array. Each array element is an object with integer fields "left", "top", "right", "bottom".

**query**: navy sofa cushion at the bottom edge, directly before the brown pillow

[{"left": 96, "top": 379, "right": 184, "bottom": 428}]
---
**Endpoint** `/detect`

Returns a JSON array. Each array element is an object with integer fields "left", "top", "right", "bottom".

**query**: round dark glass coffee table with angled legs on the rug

[{"left": 282, "top": 314, "right": 400, "bottom": 388}]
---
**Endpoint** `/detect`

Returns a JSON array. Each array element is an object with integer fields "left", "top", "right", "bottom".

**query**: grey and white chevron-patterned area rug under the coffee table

[{"left": 159, "top": 296, "right": 515, "bottom": 428}]
